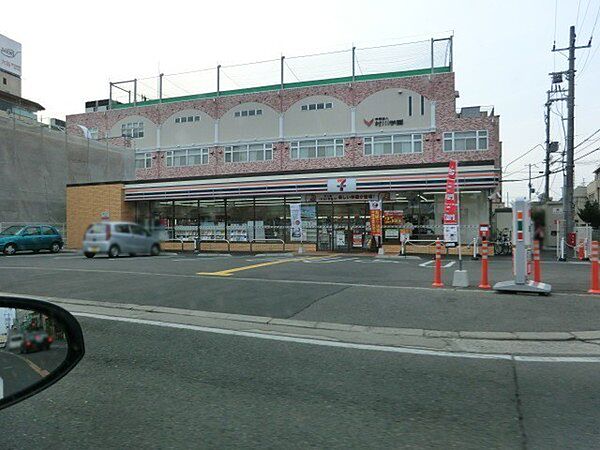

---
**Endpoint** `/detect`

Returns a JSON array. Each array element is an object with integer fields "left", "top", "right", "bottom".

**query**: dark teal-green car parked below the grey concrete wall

[{"left": 0, "top": 225, "right": 64, "bottom": 255}]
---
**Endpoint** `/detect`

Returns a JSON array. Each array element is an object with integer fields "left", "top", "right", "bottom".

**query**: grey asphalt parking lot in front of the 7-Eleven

[{"left": 0, "top": 253, "right": 600, "bottom": 331}]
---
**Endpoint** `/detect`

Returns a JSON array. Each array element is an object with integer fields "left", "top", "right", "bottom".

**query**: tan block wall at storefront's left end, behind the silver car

[{"left": 67, "top": 183, "right": 135, "bottom": 248}]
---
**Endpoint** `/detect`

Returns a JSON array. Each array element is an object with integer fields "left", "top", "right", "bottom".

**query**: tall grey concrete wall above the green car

[{"left": 0, "top": 117, "right": 134, "bottom": 223}]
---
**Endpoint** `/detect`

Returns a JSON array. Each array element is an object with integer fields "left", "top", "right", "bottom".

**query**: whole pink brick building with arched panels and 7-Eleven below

[{"left": 67, "top": 37, "right": 501, "bottom": 251}]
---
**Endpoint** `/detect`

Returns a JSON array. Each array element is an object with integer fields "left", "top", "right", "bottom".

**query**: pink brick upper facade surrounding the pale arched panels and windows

[{"left": 67, "top": 73, "right": 501, "bottom": 179}]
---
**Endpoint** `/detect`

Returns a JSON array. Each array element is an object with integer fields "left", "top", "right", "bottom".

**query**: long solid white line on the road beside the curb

[{"left": 73, "top": 312, "right": 600, "bottom": 363}]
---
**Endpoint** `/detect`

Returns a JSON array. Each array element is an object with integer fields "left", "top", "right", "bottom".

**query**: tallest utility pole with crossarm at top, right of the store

[{"left": 552, "top": 25, "right": 592, "bottom": 236}]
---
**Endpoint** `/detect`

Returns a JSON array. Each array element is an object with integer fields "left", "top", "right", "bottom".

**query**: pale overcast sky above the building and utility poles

[{"left": 0, "top": 0, "right": 600, "bottom": 199}]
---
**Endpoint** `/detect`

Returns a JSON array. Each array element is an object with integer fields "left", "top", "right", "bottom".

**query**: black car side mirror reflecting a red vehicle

[{"left": 0, "top": 296, "right": 85, "bottom": 409}]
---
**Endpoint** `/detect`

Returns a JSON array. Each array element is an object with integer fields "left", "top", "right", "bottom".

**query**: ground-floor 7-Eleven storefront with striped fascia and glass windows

[{"left": 111, "top": 163, "right": 498, "bottom": 252}]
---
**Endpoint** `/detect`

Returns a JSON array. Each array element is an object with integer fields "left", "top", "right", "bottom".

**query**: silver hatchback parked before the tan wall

[{"left": 83, "top": 222, "right": 160, "bottom": 258}]
